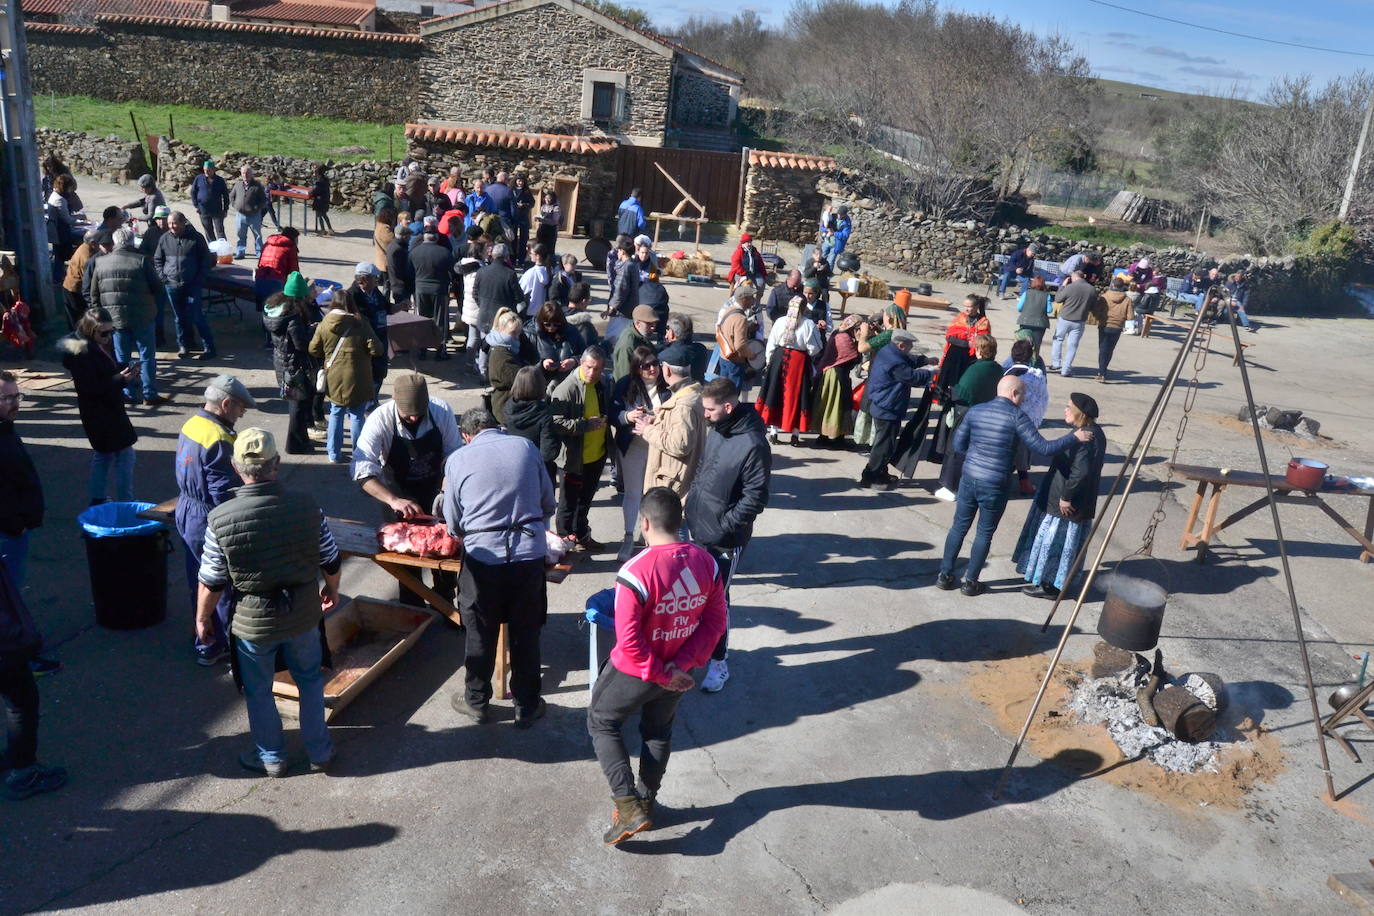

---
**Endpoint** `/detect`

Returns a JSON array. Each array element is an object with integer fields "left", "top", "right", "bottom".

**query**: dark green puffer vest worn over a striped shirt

[{"left": 207, "top": 481, "right": 320, "bottom": 643}]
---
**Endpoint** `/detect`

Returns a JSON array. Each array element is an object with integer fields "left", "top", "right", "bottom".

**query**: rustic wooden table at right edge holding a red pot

[{"left": 1168, "top": 464, "right": 1374, "bottom": 563}]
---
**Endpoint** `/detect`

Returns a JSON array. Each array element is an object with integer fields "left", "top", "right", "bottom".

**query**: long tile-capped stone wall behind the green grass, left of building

[{"left": 27, "top": 18, "right": 423, "bottom": 124}]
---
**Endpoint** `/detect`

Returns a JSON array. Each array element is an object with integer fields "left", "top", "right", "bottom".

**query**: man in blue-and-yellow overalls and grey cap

[{"left": 176, "top": 375, "right": 257, "bottom": 667}]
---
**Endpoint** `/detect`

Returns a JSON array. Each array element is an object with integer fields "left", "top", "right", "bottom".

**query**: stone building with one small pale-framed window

[{"left": 419, "top": 0, "right": 743, "bottom": 146}]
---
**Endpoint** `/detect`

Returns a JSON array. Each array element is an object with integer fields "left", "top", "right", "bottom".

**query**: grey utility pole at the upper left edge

[{"left": 0, "top": 0, "right": 56, "bottom": 320}]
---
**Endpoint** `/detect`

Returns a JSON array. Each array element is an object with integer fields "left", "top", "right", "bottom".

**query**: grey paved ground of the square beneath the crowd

[{"left": 0, "top": 181, "right": 1374, "bottom": 913}]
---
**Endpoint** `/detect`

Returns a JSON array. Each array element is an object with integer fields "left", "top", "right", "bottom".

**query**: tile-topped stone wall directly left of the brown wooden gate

[{"left": 408, "top": 140, "right": 620, "bottom": 231}]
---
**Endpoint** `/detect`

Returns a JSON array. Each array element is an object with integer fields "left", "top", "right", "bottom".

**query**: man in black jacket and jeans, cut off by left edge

[{"left": 0, "top": 369, "right": 62, "bottom": 681}]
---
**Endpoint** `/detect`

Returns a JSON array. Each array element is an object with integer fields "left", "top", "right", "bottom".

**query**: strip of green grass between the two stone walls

[{"left": 33, "top": 96, "right": 405, "bottom": 162}]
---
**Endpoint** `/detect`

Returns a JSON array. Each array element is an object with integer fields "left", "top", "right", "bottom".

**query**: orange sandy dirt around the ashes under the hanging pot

[{"left": 967, "top": 655, "right": 1285, "bottom": 812}]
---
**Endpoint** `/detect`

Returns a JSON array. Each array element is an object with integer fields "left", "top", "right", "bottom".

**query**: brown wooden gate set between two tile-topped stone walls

[{"left": 611, "top": 146, "right": 741, "bottom": 228}]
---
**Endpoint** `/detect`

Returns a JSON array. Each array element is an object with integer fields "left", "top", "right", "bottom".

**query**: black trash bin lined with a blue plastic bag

[{"left": 77, "top": 503, "right": 172, "bottom": 630}]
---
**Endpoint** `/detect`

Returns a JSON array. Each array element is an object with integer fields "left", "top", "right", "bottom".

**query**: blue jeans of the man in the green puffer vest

[{"left": 234, "top": 628, "right": 334, "bottom": 764}]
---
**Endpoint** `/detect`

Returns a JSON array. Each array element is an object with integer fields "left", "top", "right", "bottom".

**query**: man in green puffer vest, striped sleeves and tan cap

[{"left": 195, "top": 428, "right": 342, "bottom": 777}]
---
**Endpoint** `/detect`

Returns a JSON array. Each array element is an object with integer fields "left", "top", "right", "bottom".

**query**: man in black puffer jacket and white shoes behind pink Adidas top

[{"left": 687, "top": 378, "right": 772, "bottom": 694}]
